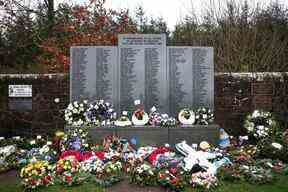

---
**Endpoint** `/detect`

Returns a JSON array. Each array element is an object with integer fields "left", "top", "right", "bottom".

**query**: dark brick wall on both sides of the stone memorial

[{"left": 0, "top": 73, "right": 288, "bottom": 136}]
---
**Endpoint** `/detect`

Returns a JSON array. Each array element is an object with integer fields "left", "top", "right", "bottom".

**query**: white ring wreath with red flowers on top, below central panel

[{"left": 132, "top": 100, "right": 149, "bottom": 126}]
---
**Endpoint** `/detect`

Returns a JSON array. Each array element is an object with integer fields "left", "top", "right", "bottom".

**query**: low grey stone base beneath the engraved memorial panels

[{"left": 89, "top": 125, "right": 219, "bottom": 146}]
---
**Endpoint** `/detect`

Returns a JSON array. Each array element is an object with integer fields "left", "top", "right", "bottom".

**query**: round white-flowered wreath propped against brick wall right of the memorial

[{"left": 244, "top": 110, "right": 276, "bottom": 140}]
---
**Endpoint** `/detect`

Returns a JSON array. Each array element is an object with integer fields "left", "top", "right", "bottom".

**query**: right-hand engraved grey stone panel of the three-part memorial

[{"left": 167, "top": 46, "right": 214, "bottom": 115}]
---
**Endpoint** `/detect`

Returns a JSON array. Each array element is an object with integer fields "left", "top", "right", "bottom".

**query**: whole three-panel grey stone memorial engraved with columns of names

[{"left": 70, "top": 34, "right": 214, "bottom": 115}]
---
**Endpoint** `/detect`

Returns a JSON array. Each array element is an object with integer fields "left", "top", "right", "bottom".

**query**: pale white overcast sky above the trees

[{"left": 55, "top": 0, "right": 288, "bottom": 29}]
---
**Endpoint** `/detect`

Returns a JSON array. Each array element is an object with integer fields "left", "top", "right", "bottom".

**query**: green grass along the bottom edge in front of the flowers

[{"left": 0, "top": 172, "right": 288, "bottom": 192}]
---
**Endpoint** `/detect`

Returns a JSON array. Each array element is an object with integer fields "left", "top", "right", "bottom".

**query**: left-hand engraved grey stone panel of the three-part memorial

[{"left": 70, "top": 46, "right": 118, "bottom": 106}]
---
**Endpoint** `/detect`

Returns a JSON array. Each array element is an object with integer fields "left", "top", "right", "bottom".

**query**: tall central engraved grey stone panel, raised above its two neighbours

[{"left": 118, "top": 34, "right": 168, "bottom": 112}]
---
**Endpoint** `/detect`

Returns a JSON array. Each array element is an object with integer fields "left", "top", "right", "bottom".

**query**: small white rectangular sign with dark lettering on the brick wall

[{"left": 8, "top": 85, "right": 32, "bottom": 97}]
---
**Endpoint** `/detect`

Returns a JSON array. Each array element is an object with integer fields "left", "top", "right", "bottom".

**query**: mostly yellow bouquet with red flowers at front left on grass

[{"left": 20, "top": 159, "right": 54, "bottom": 189}]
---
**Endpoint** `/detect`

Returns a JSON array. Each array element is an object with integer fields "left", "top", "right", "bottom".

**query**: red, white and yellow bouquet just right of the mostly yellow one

[{"left": 56, "top": 156, "right": 83, "bottom": 186}]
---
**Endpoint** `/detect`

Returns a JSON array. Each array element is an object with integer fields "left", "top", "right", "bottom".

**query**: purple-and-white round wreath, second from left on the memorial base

[{"left": 85, "top": 100, "right": 116, "bottom": 126}]
